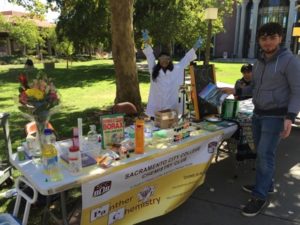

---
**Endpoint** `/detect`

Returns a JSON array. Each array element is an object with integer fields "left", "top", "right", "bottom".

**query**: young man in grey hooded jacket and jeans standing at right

[{"left": 222, "top": 22, "right": 300, "bottom": 216}]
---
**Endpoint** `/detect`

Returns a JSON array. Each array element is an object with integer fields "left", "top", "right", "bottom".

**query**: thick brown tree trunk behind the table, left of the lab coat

[{"left": 110, "top": 0, "right": 143, "bottom": 112}]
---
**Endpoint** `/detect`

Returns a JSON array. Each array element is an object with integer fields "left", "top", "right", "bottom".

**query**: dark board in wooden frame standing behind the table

[{"left": 190, "top": 63, "right": 218, "bottom": 120}]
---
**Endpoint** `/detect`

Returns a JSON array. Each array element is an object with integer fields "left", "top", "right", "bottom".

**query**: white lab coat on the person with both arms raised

[{"left": 143, "top": 46, "right": 197, "bottom": 117}]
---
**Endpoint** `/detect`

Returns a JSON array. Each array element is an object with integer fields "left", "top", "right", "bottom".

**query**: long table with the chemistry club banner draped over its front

[{"left": 10, "top": 123, "right": 237, "bottom": 225}]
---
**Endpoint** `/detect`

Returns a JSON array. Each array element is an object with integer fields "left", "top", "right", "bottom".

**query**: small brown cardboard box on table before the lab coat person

[{"left": 154, "top": 109, "right": 178, "bottom": 129}]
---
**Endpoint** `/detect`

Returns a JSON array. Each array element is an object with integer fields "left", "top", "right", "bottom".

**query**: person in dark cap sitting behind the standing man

[{"left": 234, "top": 63, "right": 252, "bottom": 100}]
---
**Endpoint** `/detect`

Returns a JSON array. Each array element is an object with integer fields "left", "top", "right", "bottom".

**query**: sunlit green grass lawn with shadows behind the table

[{"left": 0, "top": 60, "right": 241, "bottom": 224}]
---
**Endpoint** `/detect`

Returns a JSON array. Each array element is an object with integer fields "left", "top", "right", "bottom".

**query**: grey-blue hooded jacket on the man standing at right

[{"left": 237, "top": 48, "right": 300, "bottom": 121}]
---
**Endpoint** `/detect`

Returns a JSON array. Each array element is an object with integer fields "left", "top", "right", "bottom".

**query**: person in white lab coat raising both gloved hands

[{"left": 142, "top": 31, "right": 202, "bottom": 118}]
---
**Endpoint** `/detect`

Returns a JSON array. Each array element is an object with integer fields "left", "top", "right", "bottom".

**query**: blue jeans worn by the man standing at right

[{"left": 252, "top": 114, "right": 284, "bottom": 200}]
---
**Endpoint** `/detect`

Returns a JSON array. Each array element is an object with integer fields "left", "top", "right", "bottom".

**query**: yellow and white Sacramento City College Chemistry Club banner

[{"left": 81, "top": 136, "right": 220, "bottom": 225}]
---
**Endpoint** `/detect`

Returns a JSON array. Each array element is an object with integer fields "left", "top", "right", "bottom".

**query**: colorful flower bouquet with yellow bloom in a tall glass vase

[{"left": 19, "top": 71, "right": 60, "bottom": 153}]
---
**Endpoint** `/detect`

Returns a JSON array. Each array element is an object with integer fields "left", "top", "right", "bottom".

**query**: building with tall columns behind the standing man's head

[{"left": 213, "top": 0, "right": 300, "bottom": 59}]
